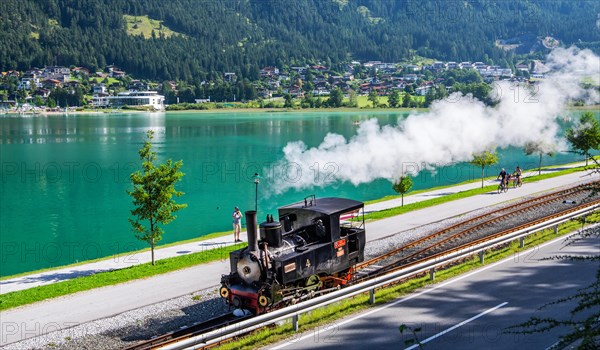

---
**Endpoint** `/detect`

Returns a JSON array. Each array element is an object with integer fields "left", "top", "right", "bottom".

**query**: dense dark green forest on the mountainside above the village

[{"left": 0, "top": 0, "right": 600, "bottom": 81}]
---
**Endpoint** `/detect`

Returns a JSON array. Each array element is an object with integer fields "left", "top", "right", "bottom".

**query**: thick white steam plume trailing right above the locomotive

[{"left": 273, "top": 48, "right": 600, "bottom": 192}]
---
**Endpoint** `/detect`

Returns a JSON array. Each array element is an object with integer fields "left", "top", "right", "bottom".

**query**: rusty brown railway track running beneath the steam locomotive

[{"left": 119, "top": 182, "right": 600, "bottom": 350}]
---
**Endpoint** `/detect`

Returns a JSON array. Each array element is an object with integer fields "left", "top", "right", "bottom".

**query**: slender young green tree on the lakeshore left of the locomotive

[{"left": 127, "top": 130, "right": 187, "bottom": 265}]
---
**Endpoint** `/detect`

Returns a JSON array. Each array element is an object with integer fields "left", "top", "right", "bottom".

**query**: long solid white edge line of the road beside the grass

[{"left": 271, "top": 232, "right": 577, "bottom": 350}]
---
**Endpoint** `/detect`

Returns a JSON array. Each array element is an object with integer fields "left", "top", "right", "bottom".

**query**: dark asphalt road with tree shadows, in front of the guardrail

[{"left": 269, "top": 231, "right": 600, "bottom": 350}]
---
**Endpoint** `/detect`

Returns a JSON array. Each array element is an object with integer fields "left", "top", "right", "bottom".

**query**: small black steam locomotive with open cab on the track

[{"left": 219, "top": 196, "right": 366, "bottom": 314}]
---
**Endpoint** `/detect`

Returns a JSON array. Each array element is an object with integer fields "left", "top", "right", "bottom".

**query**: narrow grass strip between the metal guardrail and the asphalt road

[{"left": 217, "top": 213, "right": 600, "bottom": 349}]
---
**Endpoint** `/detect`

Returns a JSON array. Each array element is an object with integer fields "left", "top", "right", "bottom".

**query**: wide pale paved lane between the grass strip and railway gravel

[{"left": 0, "top": 173, "right": 598, "bottom": 346}]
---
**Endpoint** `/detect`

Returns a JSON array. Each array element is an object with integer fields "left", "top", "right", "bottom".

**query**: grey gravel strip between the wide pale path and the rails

[{"left": 7, "top": 185, "right": 596, "bottom": 350}]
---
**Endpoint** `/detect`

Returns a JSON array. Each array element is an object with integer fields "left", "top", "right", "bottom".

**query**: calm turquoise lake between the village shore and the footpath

[{"left": 0, "top": 112, "right": 592, "bottom": 276}]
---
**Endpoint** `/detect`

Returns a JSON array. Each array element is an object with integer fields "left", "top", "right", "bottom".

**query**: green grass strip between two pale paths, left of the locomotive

[{"left": 0, "top": 243, "right": 245, "bottom": 310}]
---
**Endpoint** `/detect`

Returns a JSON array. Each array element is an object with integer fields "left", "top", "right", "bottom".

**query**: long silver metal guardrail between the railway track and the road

[{"left": 161, "top": 204, "right": 600, "bottom": 350}]
